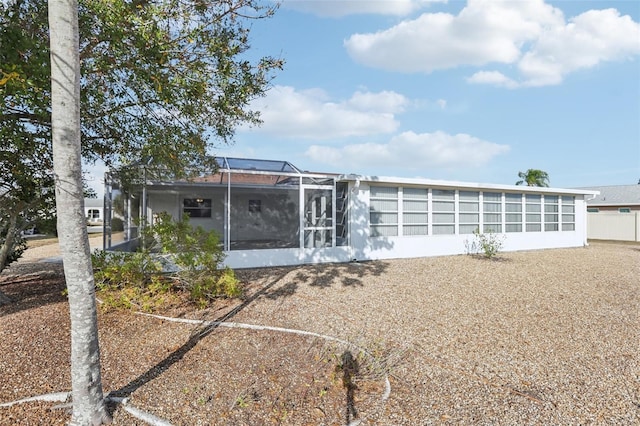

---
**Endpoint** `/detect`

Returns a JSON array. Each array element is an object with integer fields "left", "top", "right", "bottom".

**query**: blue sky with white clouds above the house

[{"left": 216, "top": 0, "right": 640, "bottom": 187}]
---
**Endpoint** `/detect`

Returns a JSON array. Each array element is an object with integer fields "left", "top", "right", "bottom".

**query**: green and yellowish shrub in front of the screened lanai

[{"left": 93, "top": 213, "right": 242, "bottom": 310}]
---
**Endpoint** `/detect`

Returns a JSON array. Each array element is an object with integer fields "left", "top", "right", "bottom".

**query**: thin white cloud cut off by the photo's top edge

[{"left": 283, "top": 0, "right": 446, "bottom": 18}]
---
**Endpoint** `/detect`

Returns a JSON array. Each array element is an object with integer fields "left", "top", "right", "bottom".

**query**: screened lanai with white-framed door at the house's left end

[{"left": 105, "top": 157, "right": 347, "bottom": 255}]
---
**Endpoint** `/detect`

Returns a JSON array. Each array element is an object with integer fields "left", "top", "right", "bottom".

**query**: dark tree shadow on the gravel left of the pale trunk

[{"left": 0, "top": 262, "right": 67, "bottom": 316}]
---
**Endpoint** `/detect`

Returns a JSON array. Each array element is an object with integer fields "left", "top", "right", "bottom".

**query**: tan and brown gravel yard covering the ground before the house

[{"left": 0, "top": 243, "right": 640, "bottom": 425}]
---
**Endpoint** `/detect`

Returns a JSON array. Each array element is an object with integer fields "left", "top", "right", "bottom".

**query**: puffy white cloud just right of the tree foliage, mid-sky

[{"left": 246, "top": 86, "right": 409, "bottom": 140}]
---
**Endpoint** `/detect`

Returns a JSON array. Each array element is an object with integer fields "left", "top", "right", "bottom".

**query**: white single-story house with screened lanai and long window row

[{"left": 105, "top": 158, "right": 597, "bottom": 268}]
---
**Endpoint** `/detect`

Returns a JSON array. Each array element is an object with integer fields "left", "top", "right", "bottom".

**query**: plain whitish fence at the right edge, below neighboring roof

[{"left": 587, "top": 212, "right": 640, "bottom": 241}]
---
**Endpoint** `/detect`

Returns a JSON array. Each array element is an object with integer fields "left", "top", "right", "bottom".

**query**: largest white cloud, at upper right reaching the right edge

[{"left": 344, "top": 0, "right": 640, "bottom": 88}]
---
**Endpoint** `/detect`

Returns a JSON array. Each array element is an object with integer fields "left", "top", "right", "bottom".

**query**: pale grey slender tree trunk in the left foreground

[{"left": 49, "top": 0, "right": 110, "bottom": 426}]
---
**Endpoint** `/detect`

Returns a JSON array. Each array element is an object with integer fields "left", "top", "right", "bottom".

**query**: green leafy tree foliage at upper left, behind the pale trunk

[{"left": 0, "top": 0, "right": 282, "bottom": 269}]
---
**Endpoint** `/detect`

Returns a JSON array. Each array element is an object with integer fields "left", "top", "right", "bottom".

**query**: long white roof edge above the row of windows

[{"left": 337, "top": 174, "right": 600, "bottom": 196}]
